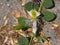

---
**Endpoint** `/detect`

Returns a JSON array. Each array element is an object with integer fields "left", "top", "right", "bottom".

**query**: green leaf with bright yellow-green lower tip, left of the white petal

[{"left": 15, "top": 17, "right": 29, "bottom": 30}]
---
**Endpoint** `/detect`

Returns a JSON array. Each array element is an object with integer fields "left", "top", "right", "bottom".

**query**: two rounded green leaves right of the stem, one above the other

[{"left": 42, "top": 0, "right": 56, "bottom": 21}]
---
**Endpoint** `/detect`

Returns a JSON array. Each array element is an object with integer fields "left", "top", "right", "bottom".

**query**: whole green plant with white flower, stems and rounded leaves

[{"left": 15, "top": 0, "right": 56, "bottom": 45}]
